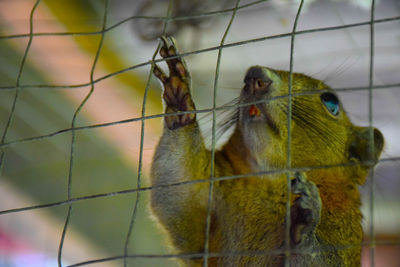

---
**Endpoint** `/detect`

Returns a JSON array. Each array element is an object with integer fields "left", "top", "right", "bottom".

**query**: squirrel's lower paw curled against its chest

[{"left": 290, "top": 172, "right": 321, "bottom": 246}]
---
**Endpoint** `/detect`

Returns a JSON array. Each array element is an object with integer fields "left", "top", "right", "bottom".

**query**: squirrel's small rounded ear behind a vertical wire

[{"left": 349, "top": 127, "right": 385, "bottom": 169}]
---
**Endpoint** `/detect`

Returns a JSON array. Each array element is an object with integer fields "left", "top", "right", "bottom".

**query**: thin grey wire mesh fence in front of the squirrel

[{"left": 0, "top": 0, "right": 400, "bottom": 266}]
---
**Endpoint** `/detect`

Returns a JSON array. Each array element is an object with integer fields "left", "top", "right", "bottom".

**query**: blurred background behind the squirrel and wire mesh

[{"left": 0, "top": 0, "right": 400, "bottom": 266}]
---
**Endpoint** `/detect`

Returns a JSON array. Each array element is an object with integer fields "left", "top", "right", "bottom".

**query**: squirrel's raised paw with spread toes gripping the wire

[{"left": 153, "top": 37, "right": 196, "bottom": 130}]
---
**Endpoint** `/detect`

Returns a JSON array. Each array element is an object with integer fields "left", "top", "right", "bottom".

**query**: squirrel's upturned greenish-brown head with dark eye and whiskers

[{"left": 238, "top": 66, "right": 384, "bottom": 183}]
